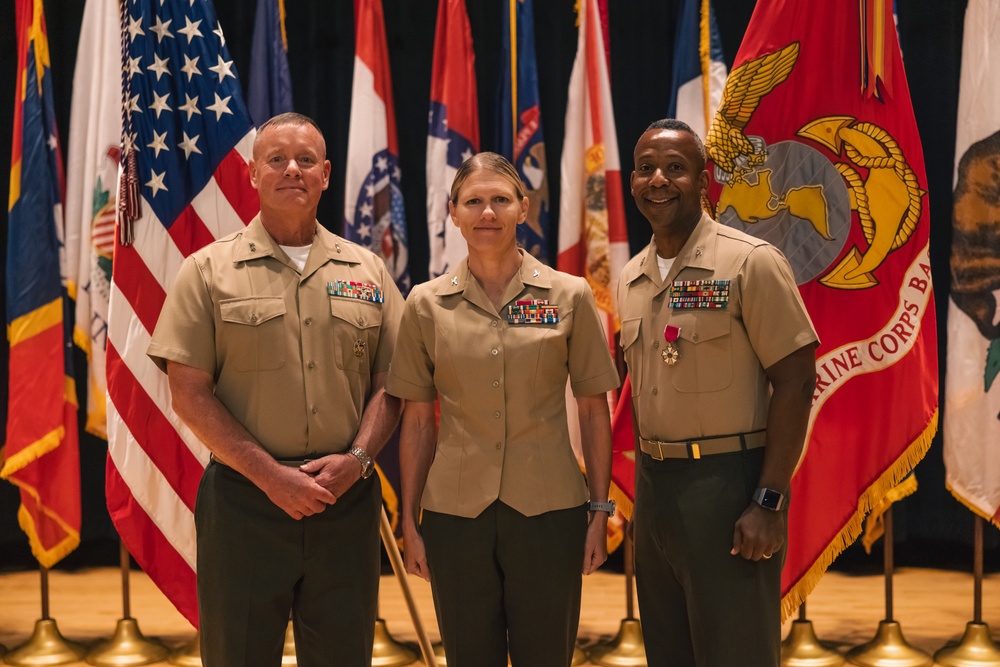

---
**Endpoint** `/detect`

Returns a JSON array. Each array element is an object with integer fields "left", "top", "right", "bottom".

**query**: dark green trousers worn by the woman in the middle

[{"left": 421, "top": 501, "right": 587, "bottom": 667}]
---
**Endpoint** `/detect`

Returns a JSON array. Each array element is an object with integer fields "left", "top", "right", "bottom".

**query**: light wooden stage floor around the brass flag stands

[{"left": 0, "top": 568, "right": 1000, "bottom": 665}]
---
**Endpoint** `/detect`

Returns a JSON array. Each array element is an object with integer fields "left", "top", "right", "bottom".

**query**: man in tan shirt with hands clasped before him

[{"left": 148, "top": 114, "right": 403, "bottom": 667}]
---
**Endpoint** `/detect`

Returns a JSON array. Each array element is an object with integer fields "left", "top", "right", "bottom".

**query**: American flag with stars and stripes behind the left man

[{"left": 106, "top": 0, "right": 259, "bottom": 627}]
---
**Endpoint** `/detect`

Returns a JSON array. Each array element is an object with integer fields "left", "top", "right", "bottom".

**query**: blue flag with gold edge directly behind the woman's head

[{"left": 497, "top": 0, "right": 550, "bottom": 264}]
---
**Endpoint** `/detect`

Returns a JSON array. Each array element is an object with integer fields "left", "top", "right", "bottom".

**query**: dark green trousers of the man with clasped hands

[{"left": 195, "top": 461, "right": 382, "bottom": 667}]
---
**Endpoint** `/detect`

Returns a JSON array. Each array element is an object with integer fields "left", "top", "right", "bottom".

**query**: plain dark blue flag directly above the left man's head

[{"left": 247, "top": 0, "right": 292, "bottom": 125}]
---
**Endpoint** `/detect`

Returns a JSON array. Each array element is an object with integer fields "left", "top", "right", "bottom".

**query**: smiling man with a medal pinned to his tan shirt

[{"left": 618, "top": 120, "right": 817, "bottom": 667}]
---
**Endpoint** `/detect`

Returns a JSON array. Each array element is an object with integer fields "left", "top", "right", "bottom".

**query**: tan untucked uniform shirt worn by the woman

[{"left": 386, "top": 252, "right": 618, "bottom": 517}]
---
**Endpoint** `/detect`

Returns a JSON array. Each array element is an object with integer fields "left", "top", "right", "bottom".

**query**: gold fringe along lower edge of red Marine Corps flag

[{"left": 781, "top": 408, "right": 938, "bottom": 623}]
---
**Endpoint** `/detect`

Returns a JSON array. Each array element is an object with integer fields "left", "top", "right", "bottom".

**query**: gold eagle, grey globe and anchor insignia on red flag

[{"left": 705, "top": 42, "right": 926, "bottom": 290}]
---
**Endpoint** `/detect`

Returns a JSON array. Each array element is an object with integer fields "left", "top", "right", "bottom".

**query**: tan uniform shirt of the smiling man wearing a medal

[{"left": 618, "top": 215, "right": 818, "bottom": 442}]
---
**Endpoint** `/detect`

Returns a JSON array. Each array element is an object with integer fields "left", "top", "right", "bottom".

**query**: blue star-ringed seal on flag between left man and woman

[{"left": 354, "top": 149, "right": 408, "bottom": 285}]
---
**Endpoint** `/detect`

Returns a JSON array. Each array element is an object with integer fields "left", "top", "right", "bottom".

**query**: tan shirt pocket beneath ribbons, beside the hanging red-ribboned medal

[{"left": 669, "top": 309, "right": 733, "bottom": 393}]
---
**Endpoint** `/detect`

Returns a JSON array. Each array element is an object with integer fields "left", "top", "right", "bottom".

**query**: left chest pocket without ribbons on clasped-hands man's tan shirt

[{"left": 219, "top": 296, "right": 286, "bottom": 371}]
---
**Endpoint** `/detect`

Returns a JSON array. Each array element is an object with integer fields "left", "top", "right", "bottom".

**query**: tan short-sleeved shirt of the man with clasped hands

[{"left": 147, "top": 217, "right": 403, "bottom": 458}]
